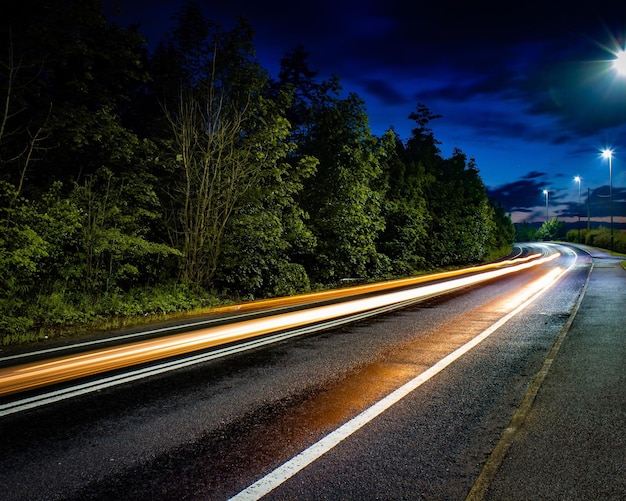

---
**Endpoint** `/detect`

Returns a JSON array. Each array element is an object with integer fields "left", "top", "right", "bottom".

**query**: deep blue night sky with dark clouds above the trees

[{"left": 110, "top": 0, "right": 626, "bottom": 222}]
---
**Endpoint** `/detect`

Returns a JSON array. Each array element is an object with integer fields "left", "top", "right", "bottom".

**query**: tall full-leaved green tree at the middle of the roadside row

[{"left": 303, "top": 90, "right": 384, "bottom": 282}]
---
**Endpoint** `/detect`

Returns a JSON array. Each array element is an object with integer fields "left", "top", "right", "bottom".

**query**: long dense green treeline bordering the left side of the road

[{"left": 0, "top": 0, "right": 514, "bottom": 342}]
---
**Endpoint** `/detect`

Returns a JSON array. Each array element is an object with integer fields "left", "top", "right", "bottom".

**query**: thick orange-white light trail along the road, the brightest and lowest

[{"left": 0, "top": 252, "right": 561, "bottom": 396}]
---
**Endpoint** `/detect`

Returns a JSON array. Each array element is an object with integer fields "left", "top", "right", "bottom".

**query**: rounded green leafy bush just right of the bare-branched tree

[{"left": 216, "top": 146, "right": 316, "bottom": 298}]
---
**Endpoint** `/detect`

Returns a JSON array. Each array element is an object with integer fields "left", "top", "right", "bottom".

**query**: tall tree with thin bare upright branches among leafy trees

[{"left": 157, "top": 4, "right": 306, "bottom": 292}]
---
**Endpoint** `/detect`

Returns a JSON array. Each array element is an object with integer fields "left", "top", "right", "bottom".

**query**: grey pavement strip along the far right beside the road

[{"left": 467, "top": 250, "right": 626, "bottom": 501}]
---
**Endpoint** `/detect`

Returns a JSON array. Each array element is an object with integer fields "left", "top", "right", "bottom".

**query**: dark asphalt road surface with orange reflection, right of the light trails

[{"left": 0, "top": 240, "right": 608, "bottom": 500}]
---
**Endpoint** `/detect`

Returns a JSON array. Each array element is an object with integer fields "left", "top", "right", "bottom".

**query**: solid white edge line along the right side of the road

[{"left": 230, "top": 254, "right": 576, "bottom": 501}]
